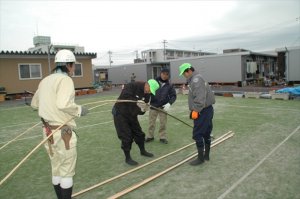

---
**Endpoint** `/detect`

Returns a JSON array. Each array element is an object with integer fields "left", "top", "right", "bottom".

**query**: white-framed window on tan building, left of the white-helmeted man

[{"left": 19, "top": 64, "right": 42, "bottom": 80}]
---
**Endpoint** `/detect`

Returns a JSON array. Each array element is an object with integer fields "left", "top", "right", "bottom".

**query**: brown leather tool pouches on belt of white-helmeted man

[{"left": 44, "top": 122, "right": 72, "bottom": 150}]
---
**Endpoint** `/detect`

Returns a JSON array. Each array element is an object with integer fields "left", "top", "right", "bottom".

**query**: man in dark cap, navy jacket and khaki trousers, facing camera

[{"left": 145, "top": 68, "right": 176, "bottom": 144}]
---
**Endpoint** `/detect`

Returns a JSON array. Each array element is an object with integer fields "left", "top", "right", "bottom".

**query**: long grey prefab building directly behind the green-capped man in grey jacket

[{"left": 170, "top": 51, "right": 277, "bottom": 85}]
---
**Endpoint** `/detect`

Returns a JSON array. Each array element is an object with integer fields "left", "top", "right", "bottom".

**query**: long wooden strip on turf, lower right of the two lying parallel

[{"left": 108, "top": 133, "right": 234, "bottom": 199}]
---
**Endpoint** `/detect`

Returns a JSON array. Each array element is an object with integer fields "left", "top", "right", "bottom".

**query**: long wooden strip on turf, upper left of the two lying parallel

[{"left": 72, "top": 131, "right": 232, "bottom": 197}]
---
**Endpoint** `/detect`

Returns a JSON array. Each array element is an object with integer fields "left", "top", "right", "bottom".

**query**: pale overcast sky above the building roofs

[{"left": 0, "top": 0, "right": 300, "bottom": 65}]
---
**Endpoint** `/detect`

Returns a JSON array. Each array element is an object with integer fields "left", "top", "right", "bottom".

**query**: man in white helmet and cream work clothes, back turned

[{"left": 31, "top": 50, "right": 88, "bottom": 199}]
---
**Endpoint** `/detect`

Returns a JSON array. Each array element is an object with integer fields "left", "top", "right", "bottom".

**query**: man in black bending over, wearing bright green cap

[{"left": 112, "top": 79, "right": 159, "bottom": 165}]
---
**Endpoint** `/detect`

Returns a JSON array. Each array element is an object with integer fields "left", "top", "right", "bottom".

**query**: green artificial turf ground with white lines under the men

[{"left": 0, "top": 94, "right": 300, "bottom": 199}]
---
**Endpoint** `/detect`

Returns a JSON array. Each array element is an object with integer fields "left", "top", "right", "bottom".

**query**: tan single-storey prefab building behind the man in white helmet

[{"left": 0, "top": 51, "right": 97, "bottom": 94}]
